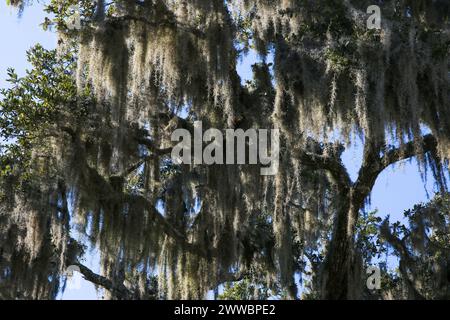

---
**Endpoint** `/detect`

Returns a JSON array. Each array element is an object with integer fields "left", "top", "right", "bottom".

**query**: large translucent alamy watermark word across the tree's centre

[{"left": 171, "top": 121, "right": 280, "bottom": 176}]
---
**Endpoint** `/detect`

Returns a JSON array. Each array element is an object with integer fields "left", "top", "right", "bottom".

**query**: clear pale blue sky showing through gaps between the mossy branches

[{"left": 0, "top": 0, "right": 442, "bottom": 299}]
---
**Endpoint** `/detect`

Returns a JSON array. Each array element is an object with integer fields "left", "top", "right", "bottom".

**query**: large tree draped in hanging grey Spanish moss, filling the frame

[{"left": 0, "top": 0, "right": 450, "bottom": 299}]
